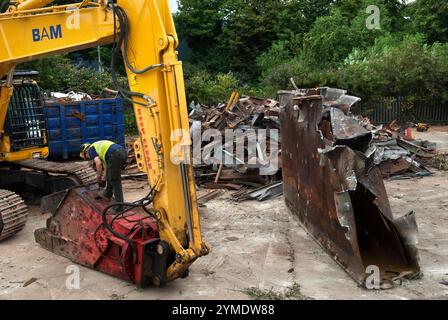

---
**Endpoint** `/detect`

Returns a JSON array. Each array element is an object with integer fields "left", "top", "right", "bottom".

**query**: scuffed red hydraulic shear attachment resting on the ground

[{"left": 35, "top": 185, "right": 174, "bottom": 287}]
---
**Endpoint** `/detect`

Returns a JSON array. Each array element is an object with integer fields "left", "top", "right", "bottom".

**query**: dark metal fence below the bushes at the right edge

[{"left": 353, "top": 97, "right": 448, "bottom": 125}]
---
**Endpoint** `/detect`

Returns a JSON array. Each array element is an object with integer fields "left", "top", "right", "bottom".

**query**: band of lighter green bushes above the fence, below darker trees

[{"left": 261, "top": 34, "right": 448, "bottom": 100}]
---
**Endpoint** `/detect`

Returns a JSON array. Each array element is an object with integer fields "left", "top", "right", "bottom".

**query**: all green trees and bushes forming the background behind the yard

[{"left": 12, "top": 0, "right": 448, "bottom": 104}]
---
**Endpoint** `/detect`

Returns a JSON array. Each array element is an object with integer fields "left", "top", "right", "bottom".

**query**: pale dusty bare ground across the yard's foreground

[{"left": 0, "top": 128, "right": 448, "bottom": 300}]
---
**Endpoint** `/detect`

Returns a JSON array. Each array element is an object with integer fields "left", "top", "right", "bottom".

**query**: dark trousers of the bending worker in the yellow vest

[{"left": 104, "top": 149, "right": 127, "bottom": 203}]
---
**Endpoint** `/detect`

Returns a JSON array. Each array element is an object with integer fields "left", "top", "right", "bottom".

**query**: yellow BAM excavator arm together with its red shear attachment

[{"left": 0, "top": 0, "right": 209, "bottom": 287}]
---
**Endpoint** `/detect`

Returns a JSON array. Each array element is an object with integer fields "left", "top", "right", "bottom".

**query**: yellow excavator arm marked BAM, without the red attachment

[{"left": 0, "top": 0, "right": 209, "bottom": 281}]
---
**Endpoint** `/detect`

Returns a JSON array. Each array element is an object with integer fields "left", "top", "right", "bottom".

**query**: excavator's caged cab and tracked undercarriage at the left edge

[{"left": 0, "top": 71, "right": 95, "bottom": 240}]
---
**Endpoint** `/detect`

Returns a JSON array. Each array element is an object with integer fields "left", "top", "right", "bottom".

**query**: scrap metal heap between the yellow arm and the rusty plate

[{"left": 190, "top": 93, "right": 282, "bottom": 201}]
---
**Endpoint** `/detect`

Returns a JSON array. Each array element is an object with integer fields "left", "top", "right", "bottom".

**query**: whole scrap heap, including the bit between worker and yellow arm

[{"left": 124, "top": 87, "right": 448, "bottom": 203}]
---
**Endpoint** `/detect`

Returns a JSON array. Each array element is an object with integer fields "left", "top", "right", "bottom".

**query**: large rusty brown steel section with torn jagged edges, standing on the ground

[{"left": 280, "top": 92, "right": 420, "bottom": 286}]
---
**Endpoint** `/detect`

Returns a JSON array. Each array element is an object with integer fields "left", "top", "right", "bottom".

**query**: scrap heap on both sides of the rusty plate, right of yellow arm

[{"left": 190, "top": 87, "right": 448, "bottom": 201}]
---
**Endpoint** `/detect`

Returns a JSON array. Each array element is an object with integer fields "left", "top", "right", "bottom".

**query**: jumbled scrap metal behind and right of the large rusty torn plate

[{"left": 279, "top": 87, "right": 448, "bottom": 179}]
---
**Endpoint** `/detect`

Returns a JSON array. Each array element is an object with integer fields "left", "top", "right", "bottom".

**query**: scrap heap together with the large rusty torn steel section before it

[{"left": 185, "top": 88, "right": 448, "bottom": 289}]
